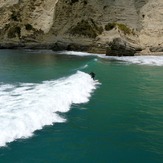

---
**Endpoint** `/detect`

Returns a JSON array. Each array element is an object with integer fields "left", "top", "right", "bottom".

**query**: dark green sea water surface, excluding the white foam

[{"left": 0, "top": 50, "right": 163, "bottom": 163}]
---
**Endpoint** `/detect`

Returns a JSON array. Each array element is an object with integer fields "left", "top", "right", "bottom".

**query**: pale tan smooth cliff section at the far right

[{"left": 139, "top": 0, "right": 163, "bottom": 47}]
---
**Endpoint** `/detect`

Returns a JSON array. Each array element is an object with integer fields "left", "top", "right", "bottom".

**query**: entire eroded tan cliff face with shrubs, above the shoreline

[{"left": 0, "top": 0, "right": 163, "bottom": 53}]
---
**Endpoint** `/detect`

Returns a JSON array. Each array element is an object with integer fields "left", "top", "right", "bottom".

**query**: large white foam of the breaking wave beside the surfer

[{"left": 0, "top": 71, "right": 98, "bottom": 146}]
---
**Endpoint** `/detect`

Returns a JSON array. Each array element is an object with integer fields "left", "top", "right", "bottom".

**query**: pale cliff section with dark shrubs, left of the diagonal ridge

[{"left": 0, "top": 0, "right": 58, "bottom": 42}]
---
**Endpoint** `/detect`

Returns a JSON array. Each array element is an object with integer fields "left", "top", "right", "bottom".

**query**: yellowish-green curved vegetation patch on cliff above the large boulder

[{"left": 105, "top": 23, "right": 134, "bottom": 35}]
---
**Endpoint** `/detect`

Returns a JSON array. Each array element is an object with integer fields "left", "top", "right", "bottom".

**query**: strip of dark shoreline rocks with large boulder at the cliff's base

[{"left": 0, "top": 39, "right": 163, "bottom": 57}]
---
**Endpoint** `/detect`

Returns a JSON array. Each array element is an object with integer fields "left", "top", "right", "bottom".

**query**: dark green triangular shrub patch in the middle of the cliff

[{"left": 70, "top": 19, "right": 103, "bottom": 38}]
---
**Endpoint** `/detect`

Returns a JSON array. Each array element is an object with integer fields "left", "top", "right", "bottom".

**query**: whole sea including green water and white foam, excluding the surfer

[{"left": 0, "top": 50, "right": 163, "bottom": 163}]
